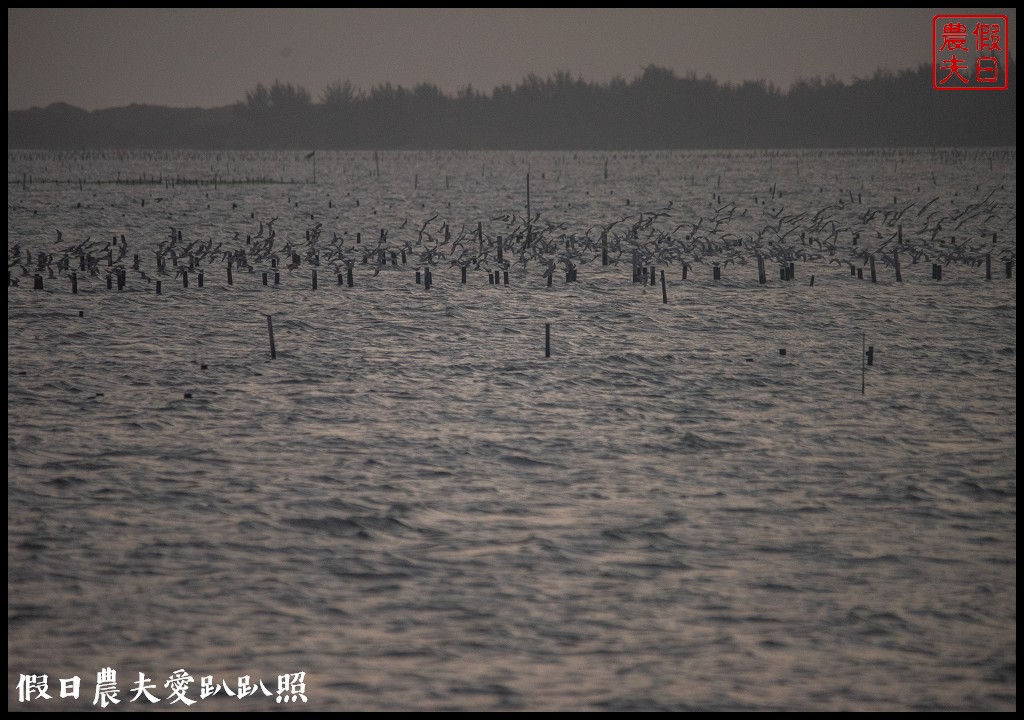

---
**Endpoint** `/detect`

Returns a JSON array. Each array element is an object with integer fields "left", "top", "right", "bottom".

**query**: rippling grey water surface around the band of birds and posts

[{"left": 7, "top": 151, "right": 1017, "bottom": 711}]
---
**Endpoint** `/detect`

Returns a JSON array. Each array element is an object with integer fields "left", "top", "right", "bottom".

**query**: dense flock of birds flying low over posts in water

[{"left": 7, "top": 194, "right": 1016, "bottom": 292}]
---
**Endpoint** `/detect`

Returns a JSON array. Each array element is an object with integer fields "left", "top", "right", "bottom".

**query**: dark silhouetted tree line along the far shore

[{"left": 7, "top": 61, "right": 1017, "bottom": 150}]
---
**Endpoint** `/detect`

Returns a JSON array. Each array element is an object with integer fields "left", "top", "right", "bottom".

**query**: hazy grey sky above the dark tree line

[{"left": 7, "top": 8, "right": 1017, "bottom": 110}]
